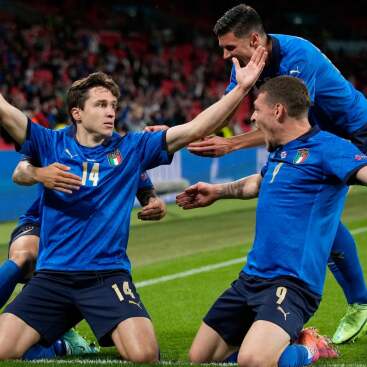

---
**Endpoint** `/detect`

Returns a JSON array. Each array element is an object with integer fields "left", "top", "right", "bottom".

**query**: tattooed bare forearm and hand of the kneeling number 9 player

[{"left": 176, "top": 174, "right": 262, "bottom": 209}]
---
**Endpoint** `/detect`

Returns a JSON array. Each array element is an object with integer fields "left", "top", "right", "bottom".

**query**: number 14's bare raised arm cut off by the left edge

[{"left": 0, "top": 94, "right": 28, "bottom": 144}]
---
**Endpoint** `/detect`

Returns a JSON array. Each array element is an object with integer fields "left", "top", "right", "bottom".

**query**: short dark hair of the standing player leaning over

[{"left": 213, "top": 4, "right": 265, "bottom": 38}]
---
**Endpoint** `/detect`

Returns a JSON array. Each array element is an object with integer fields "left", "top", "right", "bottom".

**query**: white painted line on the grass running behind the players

[{"left": 135, "top": 227, "right": 367, "bottom": 288}]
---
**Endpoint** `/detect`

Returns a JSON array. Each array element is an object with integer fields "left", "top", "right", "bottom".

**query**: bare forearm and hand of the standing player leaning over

[{"left": 187, "top": 130, "right": 265, "bottom": 157}]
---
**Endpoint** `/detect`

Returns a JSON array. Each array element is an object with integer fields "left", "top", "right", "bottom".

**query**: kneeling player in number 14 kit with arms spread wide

[{"left": 0, "top": 47, "right": 266, "bottom": 362}]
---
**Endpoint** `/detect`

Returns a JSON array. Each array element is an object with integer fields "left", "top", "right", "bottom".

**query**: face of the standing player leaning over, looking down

[{"left": 218, "top": 32, "right": 258, "bottom": 66}]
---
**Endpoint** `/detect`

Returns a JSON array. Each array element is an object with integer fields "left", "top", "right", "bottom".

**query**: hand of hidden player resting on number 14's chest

[{"left": 35, "top": 162, "right": 82, "bottom": 194}]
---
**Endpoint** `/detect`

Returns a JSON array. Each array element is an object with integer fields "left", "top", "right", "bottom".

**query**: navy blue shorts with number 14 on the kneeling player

[{"left": 3, "top": 271, "right": 149, "bottom": 346}]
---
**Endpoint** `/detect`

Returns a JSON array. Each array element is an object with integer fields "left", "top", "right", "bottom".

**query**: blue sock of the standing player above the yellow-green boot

[{"left": 329, "top": 223, "right": 367, "bottom": 304}]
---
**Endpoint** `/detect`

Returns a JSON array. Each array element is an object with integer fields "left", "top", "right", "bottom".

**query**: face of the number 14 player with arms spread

[{"left": 79, "top": 87, "right": 117, "bottom": 137}]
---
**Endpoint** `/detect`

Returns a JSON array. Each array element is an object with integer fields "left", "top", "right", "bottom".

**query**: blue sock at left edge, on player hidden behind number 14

[{"left": 0, "top": 260, "right": 23, "bottom": 308}]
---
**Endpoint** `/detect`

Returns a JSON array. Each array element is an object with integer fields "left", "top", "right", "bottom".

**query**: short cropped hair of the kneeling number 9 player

[{"left": 259, "top": 76, "right": 311, "bottom": 118}]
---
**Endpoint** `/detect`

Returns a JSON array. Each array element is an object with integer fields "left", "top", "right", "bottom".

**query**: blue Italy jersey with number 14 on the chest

[{"left": 21, "top": 121, "right": 172, "bottom": 271}]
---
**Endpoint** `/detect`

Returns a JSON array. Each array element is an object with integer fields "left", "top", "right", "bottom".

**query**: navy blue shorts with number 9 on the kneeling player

[{"left": 204, "top": 272, "right": 321, "bottom": 346}]
